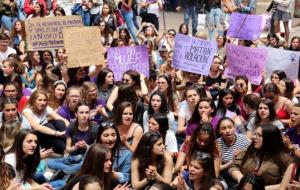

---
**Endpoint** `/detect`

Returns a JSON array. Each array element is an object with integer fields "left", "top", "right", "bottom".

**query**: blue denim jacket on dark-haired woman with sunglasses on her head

[{"left": 113, "top": 146, "right": 132, "bottom": 184}]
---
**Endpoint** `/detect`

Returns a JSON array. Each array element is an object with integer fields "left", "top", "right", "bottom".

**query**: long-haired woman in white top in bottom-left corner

[{"left": 5, "top": 129, "right": 52, "bottom": 190}]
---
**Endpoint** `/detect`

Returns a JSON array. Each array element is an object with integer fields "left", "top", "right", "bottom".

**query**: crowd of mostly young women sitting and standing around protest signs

[{"left": 0, "top": 0, "right": 300, "bottom": 190}]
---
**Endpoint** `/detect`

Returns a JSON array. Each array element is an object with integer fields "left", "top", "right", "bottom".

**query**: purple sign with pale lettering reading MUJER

[{"left": 107, "top": 46, "right": 149, "bottom": 81}]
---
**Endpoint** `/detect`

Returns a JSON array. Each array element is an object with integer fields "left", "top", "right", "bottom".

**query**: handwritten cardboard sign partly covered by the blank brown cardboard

[{"left": 25, "top": 16, "right": 83, "bottom": 51}]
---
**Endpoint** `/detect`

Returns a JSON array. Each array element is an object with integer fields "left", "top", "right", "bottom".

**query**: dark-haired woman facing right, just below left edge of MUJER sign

[{"left": 96, "top": 68, "right": 115, "bottom": 103}]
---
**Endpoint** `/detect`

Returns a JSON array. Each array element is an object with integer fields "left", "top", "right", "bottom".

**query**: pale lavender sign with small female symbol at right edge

[{"left": 265, "top": 48, "right": 300, "bottom": 79}]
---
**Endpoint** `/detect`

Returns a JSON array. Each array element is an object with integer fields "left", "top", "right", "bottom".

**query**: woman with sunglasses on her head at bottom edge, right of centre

[{"left": 171, "top": 151, "right": 223, "bottom": 190}]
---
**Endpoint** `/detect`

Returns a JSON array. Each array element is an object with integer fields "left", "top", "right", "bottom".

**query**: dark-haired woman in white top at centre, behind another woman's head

[{"left": 143, "top": 91, "right": 175, "bottom": 133}]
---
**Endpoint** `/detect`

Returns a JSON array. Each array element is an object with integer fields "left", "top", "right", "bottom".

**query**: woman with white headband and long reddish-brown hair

[{"left": 48, "top": 80, "right": 67, "bottom": 110}]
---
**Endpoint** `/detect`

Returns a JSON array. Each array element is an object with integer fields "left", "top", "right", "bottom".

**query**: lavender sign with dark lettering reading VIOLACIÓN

[{"left": 173, "top": 34, "right": 217, "bottom": 75}]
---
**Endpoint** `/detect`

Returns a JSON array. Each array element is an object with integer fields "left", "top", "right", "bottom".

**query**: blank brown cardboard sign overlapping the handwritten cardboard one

[{"left": 63, "top": 27, "right": 105, "bottom": 68}]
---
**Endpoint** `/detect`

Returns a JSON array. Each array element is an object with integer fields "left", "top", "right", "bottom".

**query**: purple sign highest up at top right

[{"left": 227, "top": 13, "right": 262, "bottom": 40}]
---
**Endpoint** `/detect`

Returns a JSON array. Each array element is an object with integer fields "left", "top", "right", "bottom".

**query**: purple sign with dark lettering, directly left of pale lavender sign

[{"left": 225, "top": 44, "right": 268, "bottom": 85}]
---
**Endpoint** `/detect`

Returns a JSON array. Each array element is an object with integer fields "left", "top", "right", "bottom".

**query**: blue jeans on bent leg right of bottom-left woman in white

[{"left": 48, "top": 154, "right": 84, "bottom": 174}]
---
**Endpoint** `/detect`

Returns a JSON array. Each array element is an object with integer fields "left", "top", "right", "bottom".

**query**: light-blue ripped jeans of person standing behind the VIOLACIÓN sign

[{"left": 208, "top": 8, "right": 223, "bottom": 40}]
